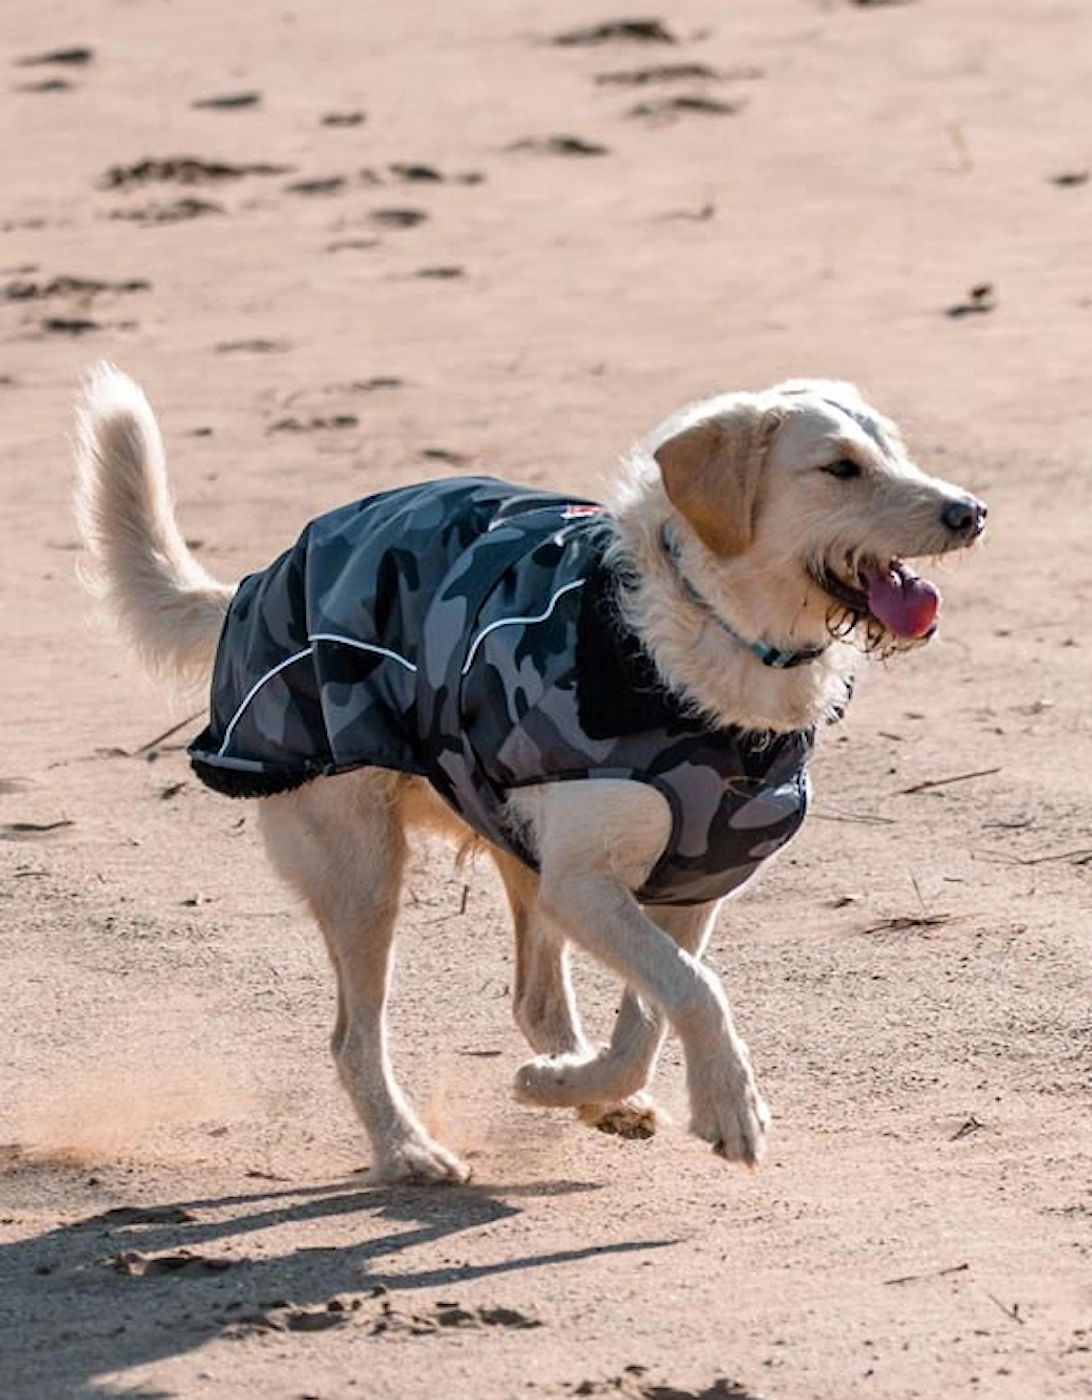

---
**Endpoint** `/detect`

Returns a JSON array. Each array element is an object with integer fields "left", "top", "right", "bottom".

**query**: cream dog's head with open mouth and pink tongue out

[{"left": 652, "top": 379, "right": 986, "bottom": 650}]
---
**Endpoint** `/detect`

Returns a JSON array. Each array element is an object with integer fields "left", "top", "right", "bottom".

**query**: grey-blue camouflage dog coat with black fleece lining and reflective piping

[{"left": 189, "top": 477, "right": 813, "bottom": 904}]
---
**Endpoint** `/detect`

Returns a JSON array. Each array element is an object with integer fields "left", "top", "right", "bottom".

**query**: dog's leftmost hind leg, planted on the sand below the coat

[{"left": 259, "top": 771, "right": 469, "bottom": 1182}]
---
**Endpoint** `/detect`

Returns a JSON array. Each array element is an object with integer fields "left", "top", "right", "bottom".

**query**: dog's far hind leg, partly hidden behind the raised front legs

[{"left": 493, "top": 848, "right": 589, "bottom": 1057}]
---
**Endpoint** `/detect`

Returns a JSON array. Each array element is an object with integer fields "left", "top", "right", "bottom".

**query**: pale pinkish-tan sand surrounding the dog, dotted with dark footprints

[{"left": 0, "top": 0, "right": 1092, "bottom": 1400}]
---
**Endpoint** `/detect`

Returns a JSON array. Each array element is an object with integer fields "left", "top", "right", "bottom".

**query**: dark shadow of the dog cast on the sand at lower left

[{"left": 0, "top": 1180, "right": 676, "bottom": 1400}]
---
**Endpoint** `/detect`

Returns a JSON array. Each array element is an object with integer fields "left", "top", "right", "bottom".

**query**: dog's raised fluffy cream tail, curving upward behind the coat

[{"left": 76, "top": 364, "right": 235, "bottom": 683}]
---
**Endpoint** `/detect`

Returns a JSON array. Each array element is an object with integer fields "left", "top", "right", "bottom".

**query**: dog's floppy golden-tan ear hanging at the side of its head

[{"left": 654, "top": 400, "right": 784, "bottom": 556}]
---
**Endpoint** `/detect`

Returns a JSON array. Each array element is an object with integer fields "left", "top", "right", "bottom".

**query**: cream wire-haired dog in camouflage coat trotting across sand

[{"left": 76, "top": 365, "right": 986, "bottom": 1182}]
